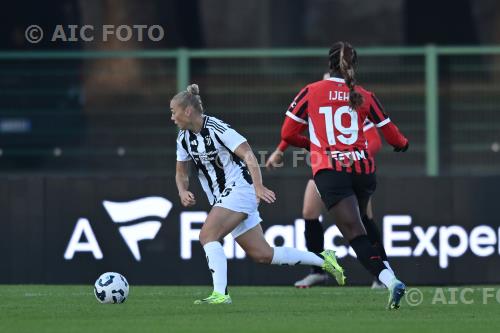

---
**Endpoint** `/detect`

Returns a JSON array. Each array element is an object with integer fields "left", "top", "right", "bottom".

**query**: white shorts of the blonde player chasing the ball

[{"left": 214, "top": 184, "right": 262, "bottom": 238}]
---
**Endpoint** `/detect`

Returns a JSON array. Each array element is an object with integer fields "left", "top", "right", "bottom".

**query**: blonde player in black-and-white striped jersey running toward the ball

[{"left": 170, "top": 84, "right": 344, "bottom": 304}]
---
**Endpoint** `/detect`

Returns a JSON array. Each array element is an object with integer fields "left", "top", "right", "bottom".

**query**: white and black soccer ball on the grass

[{"left": 94, "top": 272, "right": 128, "bottom": 304}]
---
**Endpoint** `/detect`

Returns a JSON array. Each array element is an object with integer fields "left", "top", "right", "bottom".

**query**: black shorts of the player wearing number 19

[{"left": 314, "top": 169, "right": 377, "bottom": 210}]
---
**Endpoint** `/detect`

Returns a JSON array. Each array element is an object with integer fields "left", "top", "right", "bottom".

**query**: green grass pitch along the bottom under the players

[{"left": 0, "top": 285, "right": 500, "bottom": 333}]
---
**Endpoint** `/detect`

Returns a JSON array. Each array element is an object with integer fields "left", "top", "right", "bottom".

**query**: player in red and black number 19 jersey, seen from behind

[{"left": 281, "top": 42, "right": 408, "bottom": 309}]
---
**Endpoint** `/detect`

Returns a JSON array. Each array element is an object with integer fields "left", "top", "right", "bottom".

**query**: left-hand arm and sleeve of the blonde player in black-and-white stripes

[{"left": 175, "top": 132, "right": 196, "bottom": 207}]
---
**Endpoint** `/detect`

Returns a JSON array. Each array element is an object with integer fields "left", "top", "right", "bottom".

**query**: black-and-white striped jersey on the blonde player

[{"left": 177, "top": 115, "right": 252, "bottom": 205}]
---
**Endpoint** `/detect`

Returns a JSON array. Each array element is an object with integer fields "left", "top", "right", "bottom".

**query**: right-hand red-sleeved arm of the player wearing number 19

[{"left": 368, "top": 93, "right": 409, "bottom": 151}]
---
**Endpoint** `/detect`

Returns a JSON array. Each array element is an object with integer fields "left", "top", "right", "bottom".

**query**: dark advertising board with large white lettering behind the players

[{"left": 0, "top": 176, "right": 500, "bottom": 285}]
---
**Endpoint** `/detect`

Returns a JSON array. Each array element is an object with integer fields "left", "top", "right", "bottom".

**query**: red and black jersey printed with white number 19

[{"left": 282, "top": 78, "right": 408, "bottom": 174}]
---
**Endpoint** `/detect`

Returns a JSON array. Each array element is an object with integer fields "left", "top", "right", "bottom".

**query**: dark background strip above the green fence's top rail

[{"left": 0, "top": 0, "right": 500, "bottom": 50}]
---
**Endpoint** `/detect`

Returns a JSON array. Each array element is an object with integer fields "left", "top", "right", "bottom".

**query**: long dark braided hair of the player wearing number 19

[{"left": 328, "top": 42, "right": 363, "bottom": 109}]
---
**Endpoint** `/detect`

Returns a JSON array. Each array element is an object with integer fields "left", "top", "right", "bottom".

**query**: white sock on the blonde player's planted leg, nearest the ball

[{"left": 203, "top": 242, "right": 227, "bottom": 295}]
